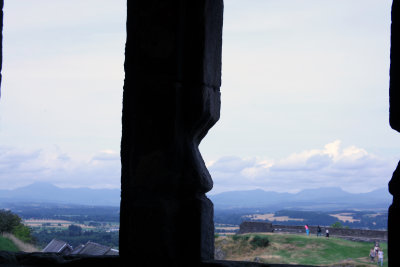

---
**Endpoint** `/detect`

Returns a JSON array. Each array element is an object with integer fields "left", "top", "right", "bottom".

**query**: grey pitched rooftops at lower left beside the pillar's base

[{"left": 42, "top": 239, "right": 119, "bottom": 256}]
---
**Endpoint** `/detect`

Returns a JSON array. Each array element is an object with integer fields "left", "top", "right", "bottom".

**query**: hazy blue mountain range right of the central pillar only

[{"left": 210, "top": 187, "right": 392, "bottom": 211}]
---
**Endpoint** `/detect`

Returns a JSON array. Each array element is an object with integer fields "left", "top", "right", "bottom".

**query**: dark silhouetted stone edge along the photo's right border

[{"left": 388, "top": 0, "right": 400, "bottom": 267}]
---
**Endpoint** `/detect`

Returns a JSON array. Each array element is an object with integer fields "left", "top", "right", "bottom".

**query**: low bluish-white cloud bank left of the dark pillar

[{"left": 0, "top": 146, "right": 121, "bottom": 189}]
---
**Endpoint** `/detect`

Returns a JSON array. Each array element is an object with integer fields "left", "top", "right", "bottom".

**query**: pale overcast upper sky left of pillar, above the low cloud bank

[{"left": 0, "top": 0, "right": 126, "bottom": 153}]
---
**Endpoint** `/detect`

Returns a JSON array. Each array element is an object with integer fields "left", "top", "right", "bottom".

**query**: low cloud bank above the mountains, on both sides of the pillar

[{"left": 0, "top": 140, "right": 397, "bottom": 194}]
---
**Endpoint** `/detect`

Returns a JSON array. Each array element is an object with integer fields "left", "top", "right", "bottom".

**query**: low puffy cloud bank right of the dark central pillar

[{"left": 209, "top": 140, "right": 397, "bottom": 194}]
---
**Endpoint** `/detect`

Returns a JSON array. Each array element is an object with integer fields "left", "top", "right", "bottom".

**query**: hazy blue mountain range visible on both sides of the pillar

[{"left": 0, "top": 183, "right": 392, "bottom": 211}]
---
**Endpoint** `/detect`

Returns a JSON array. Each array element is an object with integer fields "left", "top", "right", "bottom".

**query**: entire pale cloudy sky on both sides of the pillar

[{"left": 0, "top": 0, "right": 400, "bottom": 194}]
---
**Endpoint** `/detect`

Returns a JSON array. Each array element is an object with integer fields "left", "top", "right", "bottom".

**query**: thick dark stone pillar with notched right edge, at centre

[{"left": 120, "top": 0, "right": 223, "bottom": 266}]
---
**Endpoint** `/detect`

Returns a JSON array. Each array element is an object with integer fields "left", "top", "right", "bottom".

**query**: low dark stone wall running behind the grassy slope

[{"left": 238, "top": 222, "right": 388, "bottom": 242}]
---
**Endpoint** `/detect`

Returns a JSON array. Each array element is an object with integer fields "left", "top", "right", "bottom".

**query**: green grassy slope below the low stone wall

[{"left": 215, "top": 233, "right": 387, "bottom": 267}]
